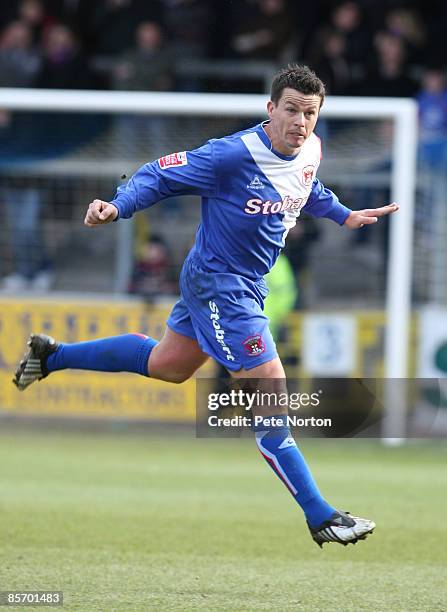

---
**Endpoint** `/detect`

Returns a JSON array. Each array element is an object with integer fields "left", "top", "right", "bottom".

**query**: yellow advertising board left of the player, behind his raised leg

[{"left": 0, "top": 299, "right": 200, "bottom": 422}]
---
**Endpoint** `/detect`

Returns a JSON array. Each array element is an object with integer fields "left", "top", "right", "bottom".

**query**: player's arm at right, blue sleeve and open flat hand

[{"left": 303, "top": 179, "right": 399, "bottom": 229}]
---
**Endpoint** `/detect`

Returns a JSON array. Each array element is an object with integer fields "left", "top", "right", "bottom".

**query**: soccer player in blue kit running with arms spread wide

[{"left": 14, "top": 64, "right": 398, "bottom": 546}]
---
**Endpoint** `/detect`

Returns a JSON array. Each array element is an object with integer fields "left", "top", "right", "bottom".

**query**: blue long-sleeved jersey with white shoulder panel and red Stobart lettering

[{"left": 112, "top": 124, "right": 351, "bottom": 280}]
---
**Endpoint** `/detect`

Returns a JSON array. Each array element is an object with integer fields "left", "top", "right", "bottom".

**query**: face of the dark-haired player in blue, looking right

[{"left": 266, "top": 87, "right": 321, "bottom": 155}]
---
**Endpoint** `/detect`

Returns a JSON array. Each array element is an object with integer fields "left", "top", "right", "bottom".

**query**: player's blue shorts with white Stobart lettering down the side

[{"left": 167, "top": 254, "right": 278, "bottom": 371}]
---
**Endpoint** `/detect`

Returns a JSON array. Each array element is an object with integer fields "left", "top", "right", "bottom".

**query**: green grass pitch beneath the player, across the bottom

[{"left": 0, "top": 433, "right": 447, "bottom": 612}]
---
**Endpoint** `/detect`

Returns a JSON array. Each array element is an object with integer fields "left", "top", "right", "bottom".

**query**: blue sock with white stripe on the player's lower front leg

[{"left": 254, "top": 415, "right": 336, "bottom": 527}]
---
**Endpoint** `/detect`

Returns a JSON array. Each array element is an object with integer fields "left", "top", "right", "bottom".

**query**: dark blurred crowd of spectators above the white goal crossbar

[{"left": 0, "top": 0, "right": 447, "bottom": 96}]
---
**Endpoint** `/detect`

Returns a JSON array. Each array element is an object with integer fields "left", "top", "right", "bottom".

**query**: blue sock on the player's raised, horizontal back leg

[{"left": 45, "top": 334, "right": 158, "bottom": 376}]
